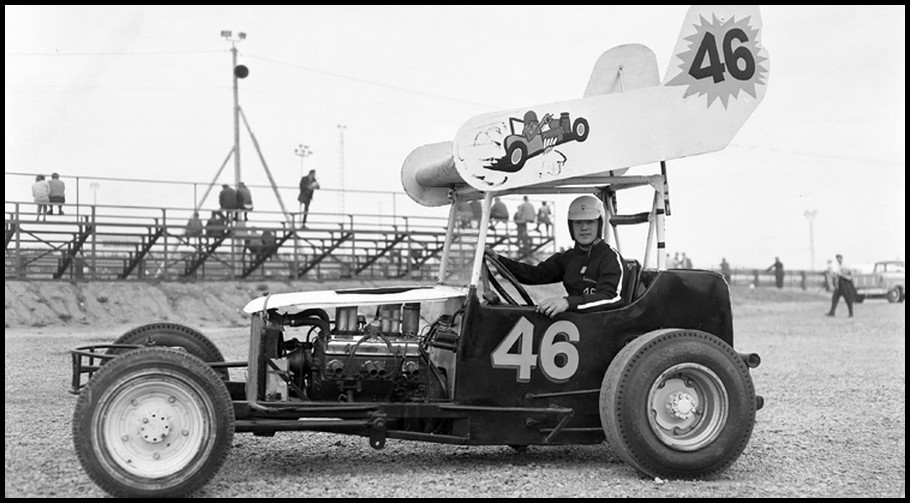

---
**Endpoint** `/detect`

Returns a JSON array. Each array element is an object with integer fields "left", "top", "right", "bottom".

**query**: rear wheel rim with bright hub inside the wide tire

[{"left": 647, "top": 363, "right": 730, "bottom": 451}]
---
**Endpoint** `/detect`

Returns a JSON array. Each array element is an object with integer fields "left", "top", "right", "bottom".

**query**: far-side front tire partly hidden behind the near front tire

[{"left": 107, "top": 323, "right": 230, "bottom": 380}]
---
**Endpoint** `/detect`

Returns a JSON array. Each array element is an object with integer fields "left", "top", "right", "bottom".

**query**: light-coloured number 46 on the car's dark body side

[{"left": 490, "top": 316, "right": 578, "bottom": 382}]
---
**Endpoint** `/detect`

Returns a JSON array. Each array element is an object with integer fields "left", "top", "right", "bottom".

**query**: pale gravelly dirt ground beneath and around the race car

[{"left": 4, "top": 287, "right": 906, "bottom": 498}]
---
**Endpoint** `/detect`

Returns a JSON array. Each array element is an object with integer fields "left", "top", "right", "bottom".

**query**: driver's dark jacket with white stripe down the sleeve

[{"left": 499, "top": 239, "right": 625, "bottom": 311}]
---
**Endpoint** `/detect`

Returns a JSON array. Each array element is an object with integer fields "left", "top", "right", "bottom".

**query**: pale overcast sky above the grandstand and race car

[{"left": 4, "top": 5, "right": 906, "bottom": 269}]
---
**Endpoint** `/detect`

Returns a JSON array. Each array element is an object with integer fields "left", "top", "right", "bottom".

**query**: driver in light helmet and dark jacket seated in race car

[{"left": 488, "top": 195, "right": 625, "bottom": 318}]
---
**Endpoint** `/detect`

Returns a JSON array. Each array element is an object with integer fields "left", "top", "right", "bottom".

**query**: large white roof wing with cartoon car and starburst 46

[{"left": 402, "top": 6, "right": 770, "bottom": 206}]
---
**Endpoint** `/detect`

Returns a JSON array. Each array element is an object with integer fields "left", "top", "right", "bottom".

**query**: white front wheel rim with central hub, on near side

[{"left": 92, "top": 373, "right": 215, "bottom": 479}]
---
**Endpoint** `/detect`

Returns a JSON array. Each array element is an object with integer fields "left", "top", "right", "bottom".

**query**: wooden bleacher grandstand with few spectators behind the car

[{"left": 5, "top": 201, "right": 554, "bottom": 281}]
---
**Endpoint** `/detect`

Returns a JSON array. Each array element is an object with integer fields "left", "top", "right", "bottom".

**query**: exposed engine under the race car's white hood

[{"left": 258, "top": 303, "right": 458, "bottom": 402}]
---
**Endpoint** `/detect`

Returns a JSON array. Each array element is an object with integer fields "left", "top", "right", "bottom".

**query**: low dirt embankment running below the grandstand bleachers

[{"left": 5, "top": 280, "right": 428, "bottom": 328}]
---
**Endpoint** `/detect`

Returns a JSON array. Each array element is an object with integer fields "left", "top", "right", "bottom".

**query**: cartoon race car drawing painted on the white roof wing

[{"left": 490, "top": 110, "right": 589, "bottom": 173}]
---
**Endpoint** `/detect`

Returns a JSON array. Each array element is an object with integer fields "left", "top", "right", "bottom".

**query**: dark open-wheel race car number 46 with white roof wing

[{"left": 71, "top": 6, "right": 767, "bottom": 497}]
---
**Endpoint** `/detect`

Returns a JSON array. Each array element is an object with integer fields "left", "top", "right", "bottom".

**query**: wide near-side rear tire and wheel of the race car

[{"left": 600, "top": 329, "right": 756, "bottom": 479}]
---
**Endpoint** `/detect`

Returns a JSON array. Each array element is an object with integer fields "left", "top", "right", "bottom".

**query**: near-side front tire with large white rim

[{"left": 73, "top": 348, "right": 234, "bottom": 498}]
